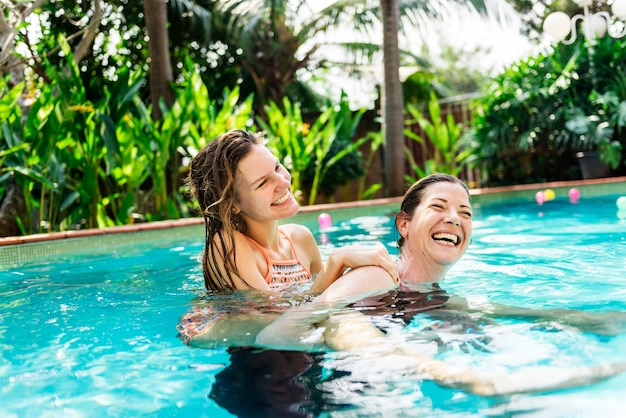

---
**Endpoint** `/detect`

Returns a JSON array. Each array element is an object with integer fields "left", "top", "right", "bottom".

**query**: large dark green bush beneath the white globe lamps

[{"left": 467, "top": 37, "right": 626, "bottom": 186}]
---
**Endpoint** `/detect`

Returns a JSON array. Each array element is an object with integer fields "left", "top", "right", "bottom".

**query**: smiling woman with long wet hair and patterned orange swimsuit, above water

[{"left": 188, "top": 130, "right": 397, "bottom": 291}]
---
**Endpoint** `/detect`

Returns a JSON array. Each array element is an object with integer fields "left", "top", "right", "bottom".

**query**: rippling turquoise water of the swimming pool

[{"left": 0, "top": 196, "right": 626, "bottom": 418}]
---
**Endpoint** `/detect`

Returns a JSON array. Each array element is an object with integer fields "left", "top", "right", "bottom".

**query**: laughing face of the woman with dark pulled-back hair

[{"left": 396, "top": 181, "right": 472, "bottom": 266}]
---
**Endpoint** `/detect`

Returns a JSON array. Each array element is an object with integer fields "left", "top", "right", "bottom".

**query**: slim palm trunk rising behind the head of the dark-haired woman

[{"left": 380, "top": 0, "right": 405, "bottom": 197}]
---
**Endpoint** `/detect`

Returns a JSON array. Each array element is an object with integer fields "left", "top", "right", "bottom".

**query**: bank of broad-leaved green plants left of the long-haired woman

[{"left": 0, "top": 38, "right": 252, "bottom": 234}]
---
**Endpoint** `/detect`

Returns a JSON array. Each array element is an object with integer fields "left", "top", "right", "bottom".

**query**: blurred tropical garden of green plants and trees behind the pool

[{"left": 0, "top": 0, "right": 626, "bottom": 236}]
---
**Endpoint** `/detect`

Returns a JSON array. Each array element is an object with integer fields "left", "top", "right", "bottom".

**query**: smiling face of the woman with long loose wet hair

[{"left": 234, "top": 145, "right": 298, "bottom": 221}]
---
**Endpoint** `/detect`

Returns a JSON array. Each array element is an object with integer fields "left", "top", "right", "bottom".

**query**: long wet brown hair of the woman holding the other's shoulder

[{"left": 187, "top": 129, "right": 263, "bottom": 290}]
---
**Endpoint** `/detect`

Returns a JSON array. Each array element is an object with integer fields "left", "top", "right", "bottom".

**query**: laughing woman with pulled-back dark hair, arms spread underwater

[{"left": 255, "top": 174, "right": 626, "bottom": 396}]
